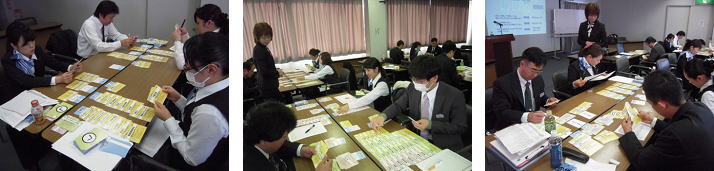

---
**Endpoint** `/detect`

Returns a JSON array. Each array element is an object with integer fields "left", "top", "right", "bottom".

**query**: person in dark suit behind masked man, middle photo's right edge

[{"left": 436, "top": 40, "right": 461, "bottom": 88}]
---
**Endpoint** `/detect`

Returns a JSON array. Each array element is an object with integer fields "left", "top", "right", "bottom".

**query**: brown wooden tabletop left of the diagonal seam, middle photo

[{"left": 290, "top": 99, "right": 380, "bottom": 170}]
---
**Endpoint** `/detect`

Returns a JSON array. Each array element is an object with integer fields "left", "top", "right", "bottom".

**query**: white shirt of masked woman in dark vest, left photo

[{"left": 164, "top": 78, "right": 229, "bottom": 166}]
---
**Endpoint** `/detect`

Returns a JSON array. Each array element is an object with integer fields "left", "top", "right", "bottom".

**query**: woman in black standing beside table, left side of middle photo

[{"left": 253, "top": 23, "right": 281, "bottom": 101}]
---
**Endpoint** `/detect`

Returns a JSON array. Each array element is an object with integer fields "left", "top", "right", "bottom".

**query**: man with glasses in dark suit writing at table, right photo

[{"left": 492, "top": 47, "right": 558, "bottom": 130}]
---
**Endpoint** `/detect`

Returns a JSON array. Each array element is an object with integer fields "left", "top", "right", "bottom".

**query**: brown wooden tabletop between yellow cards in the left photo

[{"left": 42, "top": 45, "right": 180, "bottom": 142}]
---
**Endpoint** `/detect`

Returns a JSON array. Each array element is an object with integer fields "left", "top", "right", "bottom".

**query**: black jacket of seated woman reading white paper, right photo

[{"left": 558, "top": 60, "right": 602, "bottom": 96}]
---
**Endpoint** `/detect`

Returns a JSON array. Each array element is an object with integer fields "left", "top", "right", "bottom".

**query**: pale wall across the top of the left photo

[{"left": 11, "top": 0, "right": 230, "bottom": 40}]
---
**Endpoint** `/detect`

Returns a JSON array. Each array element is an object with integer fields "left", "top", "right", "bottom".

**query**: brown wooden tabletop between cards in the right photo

[{"left": 486, "top": 81, "right": 662, "bottom": 170}]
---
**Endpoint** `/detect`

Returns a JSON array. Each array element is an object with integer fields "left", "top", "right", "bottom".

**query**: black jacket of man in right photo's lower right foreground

[{"left": 619, "top": 102, "right": 714, "bottom": 170}]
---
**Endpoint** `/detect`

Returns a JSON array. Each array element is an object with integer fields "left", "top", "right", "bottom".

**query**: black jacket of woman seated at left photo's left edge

[{"left": 2, "top": 47, "right": 70, "bottom": 99}]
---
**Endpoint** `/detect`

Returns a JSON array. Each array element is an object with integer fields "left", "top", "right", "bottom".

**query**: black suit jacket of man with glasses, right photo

[{"left": 492, "top": 71, "right": 548, "bottom": 130}]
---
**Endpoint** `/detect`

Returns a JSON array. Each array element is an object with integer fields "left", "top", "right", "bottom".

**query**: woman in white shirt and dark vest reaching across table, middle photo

[{"left": 337, "top": 57, "right": 392, "bottom": 113}]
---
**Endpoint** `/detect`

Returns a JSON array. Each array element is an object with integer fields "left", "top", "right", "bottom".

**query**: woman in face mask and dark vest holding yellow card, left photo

[{"left": 154, "top": 33, "right": 229, "bottom": 170}]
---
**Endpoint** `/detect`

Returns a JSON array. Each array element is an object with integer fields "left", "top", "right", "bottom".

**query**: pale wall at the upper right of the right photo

[{"left": 600, "top": 0, "right": 714, "bottom": 41}]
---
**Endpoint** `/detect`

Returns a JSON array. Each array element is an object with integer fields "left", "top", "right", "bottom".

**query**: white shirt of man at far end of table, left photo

[{"left": 77, "top": 16, "right": 128, "bottom": 58}]
